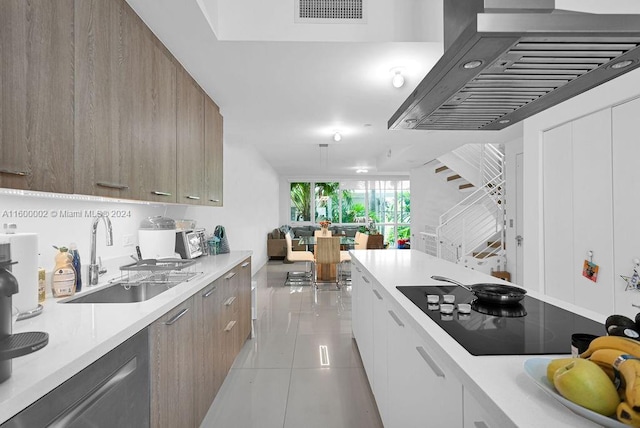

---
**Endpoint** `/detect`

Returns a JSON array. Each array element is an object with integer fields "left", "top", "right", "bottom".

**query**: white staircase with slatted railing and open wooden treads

[{"left": 423, "top": 144, "right": 506, "bottom": 273}]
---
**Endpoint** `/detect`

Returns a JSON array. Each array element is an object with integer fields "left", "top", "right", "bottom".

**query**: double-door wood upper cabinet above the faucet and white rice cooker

[{"left": 75, "top": 0, "right": 176, "bottom": 202}]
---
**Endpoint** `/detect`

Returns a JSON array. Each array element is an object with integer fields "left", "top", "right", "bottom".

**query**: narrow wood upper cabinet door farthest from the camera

[{"left": 204, "top": 96, "right": 223, "bottom": 207}]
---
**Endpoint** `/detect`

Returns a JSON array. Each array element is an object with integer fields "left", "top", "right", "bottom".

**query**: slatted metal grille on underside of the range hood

[{"left": 415, "top": 38, "right": 640, "bottom": 130}]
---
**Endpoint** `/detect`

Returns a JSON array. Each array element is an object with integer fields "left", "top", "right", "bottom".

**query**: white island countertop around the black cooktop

[{"left": 351, "top": 250, "right": 605, "bottom": 428}]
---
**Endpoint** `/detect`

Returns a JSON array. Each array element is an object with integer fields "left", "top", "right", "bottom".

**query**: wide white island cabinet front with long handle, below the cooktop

[{"left": 385, "top": 305, "right": 463, "bottom": 428}]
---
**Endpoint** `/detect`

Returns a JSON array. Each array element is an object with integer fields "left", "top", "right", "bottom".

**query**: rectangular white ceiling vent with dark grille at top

[{"left": 294, "top": 0, "right": 366, "bottom": 24}]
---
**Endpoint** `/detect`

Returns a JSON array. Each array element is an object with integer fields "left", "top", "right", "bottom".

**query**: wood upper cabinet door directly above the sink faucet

[{"left": 74, "top": 0, "right": 142, "bottom": 198}]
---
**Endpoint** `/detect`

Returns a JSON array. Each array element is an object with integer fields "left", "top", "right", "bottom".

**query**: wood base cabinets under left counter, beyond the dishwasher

[{"left": 149, "top": 258, "right": 251, "bottom": 427}]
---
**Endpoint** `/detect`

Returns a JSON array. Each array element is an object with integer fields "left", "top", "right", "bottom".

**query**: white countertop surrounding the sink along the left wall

[{"left": 0, "top": 251, "right": 252, "bottom": 423}]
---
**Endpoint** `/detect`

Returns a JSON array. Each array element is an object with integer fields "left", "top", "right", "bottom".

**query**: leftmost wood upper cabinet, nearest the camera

[{"left": 0, "top": 0, "right": 74, "bottom": 193}]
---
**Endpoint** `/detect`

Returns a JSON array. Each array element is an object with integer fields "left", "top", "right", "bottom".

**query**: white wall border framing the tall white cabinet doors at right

[{"left": 523, "top": 69, "right": 640, "bottom": 304}]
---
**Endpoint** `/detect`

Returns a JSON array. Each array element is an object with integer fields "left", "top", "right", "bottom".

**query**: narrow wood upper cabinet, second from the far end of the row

[{"left": 177, "top": 70, "right": 205, "bottom": 204}]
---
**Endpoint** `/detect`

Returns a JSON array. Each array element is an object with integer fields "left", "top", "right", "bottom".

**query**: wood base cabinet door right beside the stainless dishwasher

[{"left": 149, "top": 299, "right": 196, "bottom": 427}]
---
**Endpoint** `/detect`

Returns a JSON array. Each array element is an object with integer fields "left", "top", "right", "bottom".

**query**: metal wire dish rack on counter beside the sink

[{"left": 113, "top": 259, "right": 199, "bottom": 288}]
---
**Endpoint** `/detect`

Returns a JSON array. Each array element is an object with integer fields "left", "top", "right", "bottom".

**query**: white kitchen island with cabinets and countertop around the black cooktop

[{"left": 351, "top": 250, "right": 605, "bottom": 428}]
